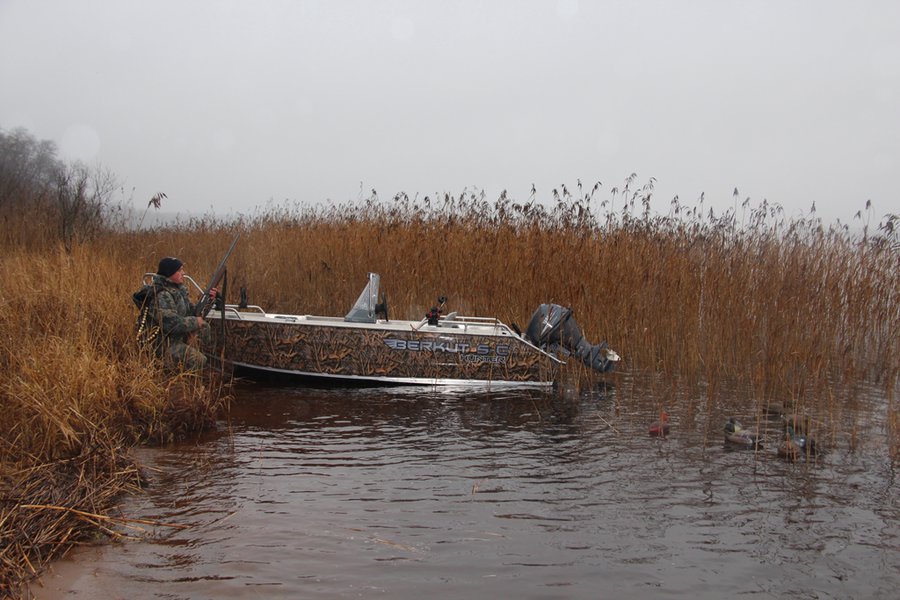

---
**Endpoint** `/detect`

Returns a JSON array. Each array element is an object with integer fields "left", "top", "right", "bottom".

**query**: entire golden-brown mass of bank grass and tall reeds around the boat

[{"left": 0, "top": 179, "right": 900, "bottom": 586}]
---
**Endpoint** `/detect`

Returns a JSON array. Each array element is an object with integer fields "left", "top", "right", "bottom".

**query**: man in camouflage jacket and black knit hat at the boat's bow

[{"left": 132, "top": 257, "right": 218, "bottom": 371}]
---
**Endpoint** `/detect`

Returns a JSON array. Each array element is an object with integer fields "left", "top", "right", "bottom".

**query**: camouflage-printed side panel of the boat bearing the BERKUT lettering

[{"left": 208, "top": 319, "right": 559, "bottom": 382}]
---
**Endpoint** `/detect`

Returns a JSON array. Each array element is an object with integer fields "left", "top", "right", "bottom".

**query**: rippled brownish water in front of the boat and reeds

[{"left": 33, "top": 381, "right": 900, "bottom": 600}]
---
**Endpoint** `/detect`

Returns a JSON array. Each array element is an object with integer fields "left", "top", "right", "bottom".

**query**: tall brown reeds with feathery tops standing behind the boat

[{"left": 132, "top": 190, "right": 900, "bottom": 448}]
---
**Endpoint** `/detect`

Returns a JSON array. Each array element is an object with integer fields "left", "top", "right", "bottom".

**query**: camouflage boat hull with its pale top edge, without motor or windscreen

[{"left": 204, "top": 313, "right": 561, "bottom": 387}]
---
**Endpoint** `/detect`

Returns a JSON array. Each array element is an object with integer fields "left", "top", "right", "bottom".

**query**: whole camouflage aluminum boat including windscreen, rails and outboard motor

[{"left": 203, "top": 273, "right": 619, "bottom": 387}]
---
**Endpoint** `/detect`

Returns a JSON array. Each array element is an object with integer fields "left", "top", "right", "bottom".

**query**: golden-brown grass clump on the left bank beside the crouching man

[{"left": 0, "top": 243, "right": 223, "bottom": 595}]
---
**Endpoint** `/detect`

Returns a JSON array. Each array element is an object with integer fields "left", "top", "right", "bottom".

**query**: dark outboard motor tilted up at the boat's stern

[{"left": 525, "top": 304, "right": 619, "bottom": 373}]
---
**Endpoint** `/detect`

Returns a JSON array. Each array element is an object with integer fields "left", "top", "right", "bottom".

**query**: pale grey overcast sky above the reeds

[{"left": 0, "top": 0, "right": 900, "bottom": 223}]
